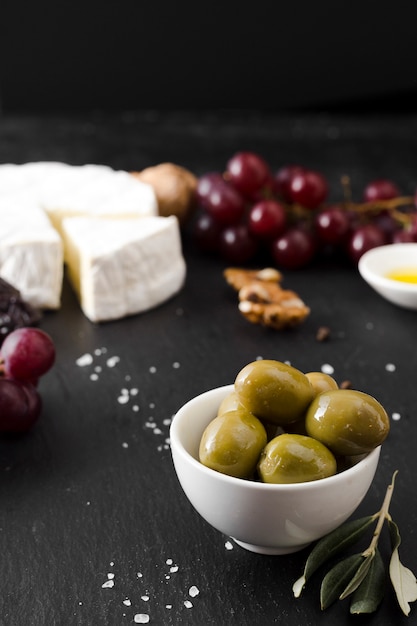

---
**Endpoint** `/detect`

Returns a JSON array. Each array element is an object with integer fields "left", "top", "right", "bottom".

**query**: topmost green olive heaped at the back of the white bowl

[{"left": 235, "top": 359, "right": 314, "bottom": 426}]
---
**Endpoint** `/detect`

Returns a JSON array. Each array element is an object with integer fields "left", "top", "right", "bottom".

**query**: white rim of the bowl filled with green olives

[{"left": 170, "top": 384, "right": 382, "bottom": 492}]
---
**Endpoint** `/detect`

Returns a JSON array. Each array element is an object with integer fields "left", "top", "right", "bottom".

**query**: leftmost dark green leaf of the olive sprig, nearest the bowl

[{"left": 292, "top": 515, "right": 375, "bottom": 598}]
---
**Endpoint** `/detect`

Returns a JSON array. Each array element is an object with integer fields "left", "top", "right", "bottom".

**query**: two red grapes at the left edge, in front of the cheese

[{"left": 0, "top": 327, "right": 55, "bottom": 433}]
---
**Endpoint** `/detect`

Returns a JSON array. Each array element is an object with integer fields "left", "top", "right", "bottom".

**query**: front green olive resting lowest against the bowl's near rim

[{"left": 258, "top": 433, "right": 337, "bottom": 484}]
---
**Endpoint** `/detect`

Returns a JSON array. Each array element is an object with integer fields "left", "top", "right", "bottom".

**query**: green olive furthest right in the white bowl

[{"left": 306, "top": 389, "right": 390, "bottom": 455}]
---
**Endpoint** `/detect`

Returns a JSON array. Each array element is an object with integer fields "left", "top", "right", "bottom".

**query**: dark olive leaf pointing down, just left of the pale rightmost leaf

[{"left": 350, "top": 549, "right": 386, "bottom": 614}]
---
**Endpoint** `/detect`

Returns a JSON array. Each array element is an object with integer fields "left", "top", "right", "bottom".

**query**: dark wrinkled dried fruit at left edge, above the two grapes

[{"left": 0, "top": 278, "right": 42, "bottom": 346}]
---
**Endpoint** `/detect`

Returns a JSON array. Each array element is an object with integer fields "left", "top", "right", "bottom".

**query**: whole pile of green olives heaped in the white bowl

[{"left": 199, "top": 360, "right": 390, "bottom": 484}]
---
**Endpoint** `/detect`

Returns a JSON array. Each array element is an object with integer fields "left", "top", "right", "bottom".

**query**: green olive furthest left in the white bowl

[{"left": 199, "top": 409, "right": 267, "bottom": 478}]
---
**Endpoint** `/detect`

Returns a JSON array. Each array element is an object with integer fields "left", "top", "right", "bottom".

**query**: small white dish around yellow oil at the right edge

[{"left": 358, "top": 243, "right": 417, "bottom": 310}]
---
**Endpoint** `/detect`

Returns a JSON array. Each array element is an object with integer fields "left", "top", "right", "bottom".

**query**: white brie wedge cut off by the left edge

[{"left": 0, "top": 198, "right": 64, "bottom": 309}]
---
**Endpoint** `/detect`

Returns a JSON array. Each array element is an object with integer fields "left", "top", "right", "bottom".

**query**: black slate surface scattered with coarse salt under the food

[{"left": 0, "top": 114, "right": 417, "bottom": 626}]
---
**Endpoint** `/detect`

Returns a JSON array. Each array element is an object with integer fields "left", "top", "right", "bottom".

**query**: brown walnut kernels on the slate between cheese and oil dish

[{"left": 224, "top": 267, "right": 310, "bottom": 330}]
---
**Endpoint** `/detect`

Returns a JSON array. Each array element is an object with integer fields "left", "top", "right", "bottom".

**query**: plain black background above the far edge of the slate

[{"left": 0, "top": 0, "right": 417, "bottom": 112}]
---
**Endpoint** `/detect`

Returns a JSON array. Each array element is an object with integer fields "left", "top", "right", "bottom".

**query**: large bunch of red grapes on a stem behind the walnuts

[{"left": 193, "top": 152, "right": 417, "bottom": 269}]
